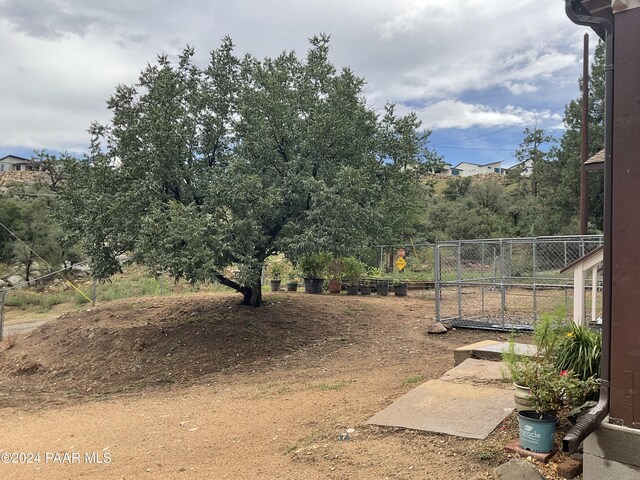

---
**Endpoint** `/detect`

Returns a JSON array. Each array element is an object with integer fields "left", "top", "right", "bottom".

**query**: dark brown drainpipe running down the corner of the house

[{"left": 562, "top": 0, "right": 613, "bottom": 453}]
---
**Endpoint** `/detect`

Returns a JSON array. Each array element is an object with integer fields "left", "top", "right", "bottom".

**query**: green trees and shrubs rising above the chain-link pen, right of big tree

[{"left": 414, "top": 43, "right": 604, "bottom": 242}]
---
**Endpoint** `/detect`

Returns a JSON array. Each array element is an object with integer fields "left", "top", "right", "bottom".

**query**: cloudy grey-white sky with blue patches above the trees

[{"left": 0, "top": 0, "right": 597, "bottom": 166}]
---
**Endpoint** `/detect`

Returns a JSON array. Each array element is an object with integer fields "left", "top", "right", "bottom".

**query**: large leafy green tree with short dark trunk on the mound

[{"left": 60, "top": 35, "right": 441, "bottom": 305}]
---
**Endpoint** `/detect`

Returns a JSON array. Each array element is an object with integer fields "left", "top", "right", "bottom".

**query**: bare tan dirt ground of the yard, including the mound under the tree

[{"left": 0, "top": 292, "right": 576, "bottom": 479}]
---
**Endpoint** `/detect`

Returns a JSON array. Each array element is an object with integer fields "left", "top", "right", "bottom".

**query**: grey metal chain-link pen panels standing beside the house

[{"left": 434, "top": 235, "right": 603, "bottom": 330}]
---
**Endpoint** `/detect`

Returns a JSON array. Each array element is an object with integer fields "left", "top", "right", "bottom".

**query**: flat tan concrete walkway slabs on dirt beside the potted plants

[{"left": 367, "top": 359, "right": 514, "bottom": 439}]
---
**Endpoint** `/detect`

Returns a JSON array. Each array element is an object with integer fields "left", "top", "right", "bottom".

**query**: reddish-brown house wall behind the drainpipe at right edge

[{"left": 605, "top": 2, "right": 640, "bottom": 432}]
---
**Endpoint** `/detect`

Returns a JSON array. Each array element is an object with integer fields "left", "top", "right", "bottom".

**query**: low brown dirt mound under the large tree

[{"left": 0, "top": 294, "right": 400, "bottom": 406}]
